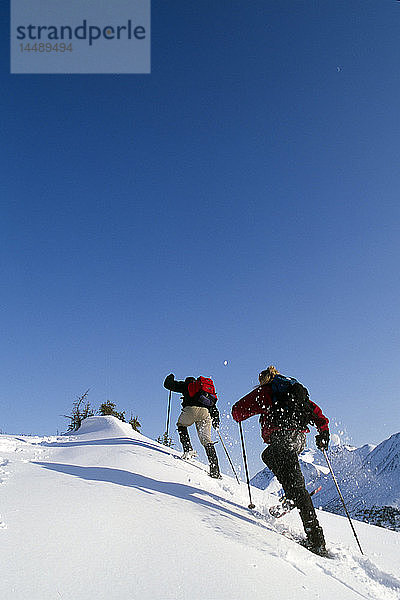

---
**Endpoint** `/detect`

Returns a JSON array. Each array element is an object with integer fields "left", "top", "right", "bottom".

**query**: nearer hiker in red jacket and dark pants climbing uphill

[{"left": 232, "top": 365, "right": 329, "bottom": 554}]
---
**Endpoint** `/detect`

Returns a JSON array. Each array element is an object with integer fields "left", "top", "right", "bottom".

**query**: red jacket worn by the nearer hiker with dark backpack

[{"left": 232, "top": 383, "right": 329, "bottom": 444}]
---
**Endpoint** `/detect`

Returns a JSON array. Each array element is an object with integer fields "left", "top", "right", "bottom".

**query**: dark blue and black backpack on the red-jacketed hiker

[{"left": 271, "top": 374, "right": 313, "bottom": 429}]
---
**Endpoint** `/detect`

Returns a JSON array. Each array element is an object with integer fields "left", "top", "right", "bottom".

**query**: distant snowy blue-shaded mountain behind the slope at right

[{"left": 251, "top": 433, "right": 400, "bottom": 531}]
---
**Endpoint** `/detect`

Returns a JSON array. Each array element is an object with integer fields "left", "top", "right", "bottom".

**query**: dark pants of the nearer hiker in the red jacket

[{"left": 261, "top": 431, "right": 325, "bottom": 546}]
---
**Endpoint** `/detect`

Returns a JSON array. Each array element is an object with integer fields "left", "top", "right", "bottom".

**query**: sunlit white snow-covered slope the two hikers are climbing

[{"left": 0, "top": 417, "right": 400, "bottom": 600}]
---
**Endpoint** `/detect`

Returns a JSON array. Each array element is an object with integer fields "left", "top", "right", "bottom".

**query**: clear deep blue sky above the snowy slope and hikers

[{"left": 0, "top": 0, "right": 400, "bottom": 476}]
